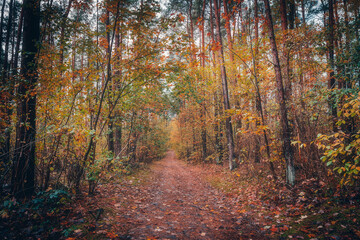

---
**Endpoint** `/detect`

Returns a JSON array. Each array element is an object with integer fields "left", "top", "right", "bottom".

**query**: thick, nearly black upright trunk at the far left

[{"left": 12, "top": 0, "right": 40, "bottom": 198}]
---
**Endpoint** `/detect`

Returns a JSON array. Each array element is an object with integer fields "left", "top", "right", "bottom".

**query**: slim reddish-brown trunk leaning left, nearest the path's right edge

[{"left": 214, "top": 0, "right": 236, "bottom": 170}]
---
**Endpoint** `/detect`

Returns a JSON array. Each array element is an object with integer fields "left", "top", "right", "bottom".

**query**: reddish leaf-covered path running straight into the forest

[{"left": 84, "top": 151, "right": 264, "bottom": 239}]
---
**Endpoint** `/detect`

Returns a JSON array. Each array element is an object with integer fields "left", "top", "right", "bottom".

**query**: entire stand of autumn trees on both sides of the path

[{"left": 0, "top": 0, "right": 360, "bottom": 197}]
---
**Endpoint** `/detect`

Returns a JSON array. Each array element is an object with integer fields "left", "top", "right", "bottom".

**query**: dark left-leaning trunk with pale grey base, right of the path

[{"left": 264, "top": 0, "right": 295, "bottom": 186}]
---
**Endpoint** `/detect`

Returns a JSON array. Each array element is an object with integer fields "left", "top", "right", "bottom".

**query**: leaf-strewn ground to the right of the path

[{"left": 202, "top": 164, "right": 360, "bottom": 239}]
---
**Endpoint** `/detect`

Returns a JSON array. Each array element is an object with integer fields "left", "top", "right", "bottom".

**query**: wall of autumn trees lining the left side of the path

[{"left": 0, "top": 0, "right": 177, "bottom": 198}]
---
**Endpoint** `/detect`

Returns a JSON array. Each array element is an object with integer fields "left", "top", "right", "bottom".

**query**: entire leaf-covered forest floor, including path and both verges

[{"left": 0, "top": 151, "right": 360, "bottom": 240}]
